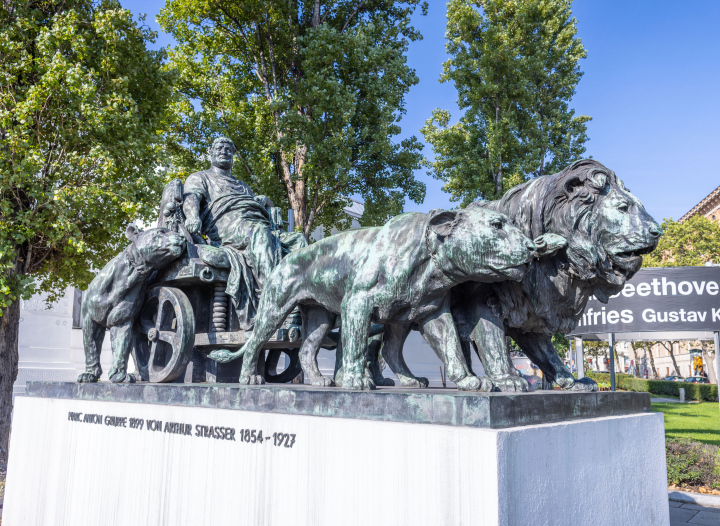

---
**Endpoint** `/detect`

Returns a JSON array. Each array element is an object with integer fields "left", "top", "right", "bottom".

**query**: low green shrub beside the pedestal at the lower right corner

[{"left": 665, "top": 439, "right": 720, "bottom": 489}]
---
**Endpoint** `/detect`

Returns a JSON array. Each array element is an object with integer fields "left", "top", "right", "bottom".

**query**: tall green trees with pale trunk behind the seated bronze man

[{"left": 159, "top": 0, "right": 427, "bottom": 235}]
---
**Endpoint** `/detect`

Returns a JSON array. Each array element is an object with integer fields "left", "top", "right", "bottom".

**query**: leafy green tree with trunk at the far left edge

[{"left": 0, "top": 0, "right": 171, "bottom": 470}]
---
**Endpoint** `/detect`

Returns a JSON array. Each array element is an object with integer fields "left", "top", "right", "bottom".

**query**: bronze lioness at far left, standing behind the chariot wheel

[{"left": 78, "top": 225, "right": 185, "bottom": 383}]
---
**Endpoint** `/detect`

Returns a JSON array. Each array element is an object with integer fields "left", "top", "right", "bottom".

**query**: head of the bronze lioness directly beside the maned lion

[{"left": 428, "top": 208, "right": 536, "bottom": 282}]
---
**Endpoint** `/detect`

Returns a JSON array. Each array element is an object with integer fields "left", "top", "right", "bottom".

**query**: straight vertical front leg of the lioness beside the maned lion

[{"left": 340, "top": 292, "right": 375, "bottom": 389}]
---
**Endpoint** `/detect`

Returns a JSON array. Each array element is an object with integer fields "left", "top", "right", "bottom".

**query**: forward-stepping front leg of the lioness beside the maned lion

[{"left": 420, "top": 301, "right": 493, "bottom": 391}]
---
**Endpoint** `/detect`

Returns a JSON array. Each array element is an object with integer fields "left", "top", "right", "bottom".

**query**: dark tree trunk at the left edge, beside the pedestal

[{"left": 0, "top": 300, "right": 20, "bottom": 471}]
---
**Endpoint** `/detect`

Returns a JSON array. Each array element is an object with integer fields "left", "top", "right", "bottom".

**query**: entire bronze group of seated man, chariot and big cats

[{"left": 78, "top": 138, "right": 662, "bottom": 391}]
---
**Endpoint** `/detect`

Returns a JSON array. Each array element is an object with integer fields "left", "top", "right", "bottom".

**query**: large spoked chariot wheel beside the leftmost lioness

[{"left": 133, "top": 287, "right": 195, "bottom": 383}]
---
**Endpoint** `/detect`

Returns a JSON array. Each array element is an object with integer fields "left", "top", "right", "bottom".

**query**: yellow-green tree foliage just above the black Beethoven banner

[{"left": 643, "top": 216, "right": 720, "bottom": 267}]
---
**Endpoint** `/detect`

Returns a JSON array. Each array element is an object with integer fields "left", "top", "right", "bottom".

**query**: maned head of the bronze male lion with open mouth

[{"left": 545, "top": 159, "right": 662, "bottom": 301}]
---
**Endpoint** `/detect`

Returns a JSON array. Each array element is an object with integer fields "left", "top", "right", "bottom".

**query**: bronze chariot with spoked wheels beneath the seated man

[{"left": 133, "top": 188, "right": 312, "bottom": 383}]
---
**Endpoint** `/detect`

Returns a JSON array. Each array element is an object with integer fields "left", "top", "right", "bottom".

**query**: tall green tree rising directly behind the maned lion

[{"left": 422, "top": 0, "right": 590, "bottom": 204}]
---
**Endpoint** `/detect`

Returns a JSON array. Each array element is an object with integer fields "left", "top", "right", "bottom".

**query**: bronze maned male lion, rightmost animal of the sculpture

[{"left": 452, "top": 159, "right": 662, "bottom": 391}]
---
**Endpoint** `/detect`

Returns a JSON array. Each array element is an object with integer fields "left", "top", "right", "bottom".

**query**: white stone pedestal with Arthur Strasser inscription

[{"left": 2, "top": 396, "right": 669, "bottom": 526}]
